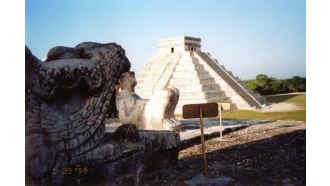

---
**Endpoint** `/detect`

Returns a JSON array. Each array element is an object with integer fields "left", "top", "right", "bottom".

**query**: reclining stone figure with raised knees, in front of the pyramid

[{"left": 116, "top": 72, "right": 180, "bottom": 130}]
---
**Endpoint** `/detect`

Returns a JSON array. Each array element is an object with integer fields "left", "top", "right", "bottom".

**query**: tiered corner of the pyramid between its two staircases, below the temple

[{"left": 167, "top": 52, "right": 235, "bottom": 113}]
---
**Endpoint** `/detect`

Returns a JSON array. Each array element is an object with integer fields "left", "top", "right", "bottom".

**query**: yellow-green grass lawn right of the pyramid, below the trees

[{"left": 222, "top": 94, "right": 306, "bottom": 122}]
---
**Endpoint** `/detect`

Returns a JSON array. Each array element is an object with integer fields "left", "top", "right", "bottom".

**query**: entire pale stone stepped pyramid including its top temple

[{"left": 135, "top": 36, "right": 263, "bottom": 114}]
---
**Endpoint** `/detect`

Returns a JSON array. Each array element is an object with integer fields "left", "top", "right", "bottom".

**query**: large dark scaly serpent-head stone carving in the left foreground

[{"left": 25, "top": 42, "right": 141, "bottom": 185}]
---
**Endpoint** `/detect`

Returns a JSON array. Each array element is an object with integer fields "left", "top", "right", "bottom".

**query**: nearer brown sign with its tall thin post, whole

[{"left": 182, "top": 103, "right": 218, "bottom": 179}]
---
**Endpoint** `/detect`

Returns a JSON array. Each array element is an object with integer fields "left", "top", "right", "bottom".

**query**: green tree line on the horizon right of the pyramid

[{"left": 245, "top": 74, "right": 306, "bottom": 95}]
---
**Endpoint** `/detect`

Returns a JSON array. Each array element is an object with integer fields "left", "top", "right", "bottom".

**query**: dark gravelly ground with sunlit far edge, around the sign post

[{"left": 144, "top": 121, "right": 306, "bottom": 185}]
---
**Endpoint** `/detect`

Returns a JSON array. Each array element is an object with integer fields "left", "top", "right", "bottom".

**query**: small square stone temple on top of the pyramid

[{"left": 158, "top": 36, "right": 201, "bottom": 53}]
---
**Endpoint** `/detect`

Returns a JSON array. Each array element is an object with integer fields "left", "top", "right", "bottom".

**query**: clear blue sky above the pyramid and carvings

[{"left": 25, "top": 0, "right": 306, "bottom": 79}]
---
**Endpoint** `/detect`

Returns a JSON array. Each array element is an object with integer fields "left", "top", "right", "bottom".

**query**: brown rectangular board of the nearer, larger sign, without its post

[{"left": 182, "top": 103, "right": 218, "bottom": 119}]
